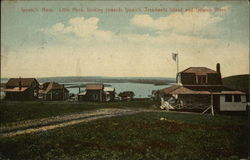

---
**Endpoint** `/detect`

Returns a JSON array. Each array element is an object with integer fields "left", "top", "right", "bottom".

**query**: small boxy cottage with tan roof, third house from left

[{"left": 85, "top": 84, "right": 104, "bottom": 102}]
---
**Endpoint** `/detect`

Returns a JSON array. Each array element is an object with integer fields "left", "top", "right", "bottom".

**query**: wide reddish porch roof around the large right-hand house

[{"left": 160, "top": 85, "right": 245, "bottom": 94}]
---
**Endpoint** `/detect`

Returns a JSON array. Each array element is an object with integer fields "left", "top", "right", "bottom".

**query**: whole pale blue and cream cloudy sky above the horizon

[{"left": 1, "top": 1, "right": 249, "bottom": 78}]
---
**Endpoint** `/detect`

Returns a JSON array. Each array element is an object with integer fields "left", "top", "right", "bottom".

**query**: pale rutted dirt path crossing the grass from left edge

[{"left": 0, "top": 108, "right": 148, "bottom": 137}]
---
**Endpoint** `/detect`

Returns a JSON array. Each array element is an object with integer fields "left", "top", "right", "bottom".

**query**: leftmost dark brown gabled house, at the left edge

[{"left": 4, "top": 78, "right": 39, "bottom": 100}]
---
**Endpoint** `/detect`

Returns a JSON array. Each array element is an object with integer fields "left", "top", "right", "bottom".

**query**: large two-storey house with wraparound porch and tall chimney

[{"left": 160, "top": 64, "right": 246, "bottom": 111}]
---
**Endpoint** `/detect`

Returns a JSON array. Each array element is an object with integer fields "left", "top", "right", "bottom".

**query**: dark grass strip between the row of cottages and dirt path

[{"left": 0, "top": 100, "right": 159, "bottom": 125}]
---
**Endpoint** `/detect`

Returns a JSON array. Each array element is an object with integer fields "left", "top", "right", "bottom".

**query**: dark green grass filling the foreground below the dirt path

[{"left": 0, "top": 112, "right": 247, "bottom": 160}]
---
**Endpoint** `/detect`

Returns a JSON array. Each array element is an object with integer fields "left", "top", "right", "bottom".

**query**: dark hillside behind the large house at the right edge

[{"left": 222, "top": 74, "right": 250, "bottom": 93}]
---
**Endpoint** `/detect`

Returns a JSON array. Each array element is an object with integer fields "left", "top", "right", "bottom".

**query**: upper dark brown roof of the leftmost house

[{"left": 6, "top": 78, "right": 37, "bottom": 87}]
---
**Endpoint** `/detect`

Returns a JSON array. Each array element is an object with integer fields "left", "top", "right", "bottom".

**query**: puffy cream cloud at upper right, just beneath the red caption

[{"left": 131, "top": 12, "right": 223, "bottom": 33}]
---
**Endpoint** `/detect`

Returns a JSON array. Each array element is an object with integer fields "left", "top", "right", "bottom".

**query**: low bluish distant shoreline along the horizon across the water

[{"left": 1, "top": 76, "right": 175, "bottom": 85}]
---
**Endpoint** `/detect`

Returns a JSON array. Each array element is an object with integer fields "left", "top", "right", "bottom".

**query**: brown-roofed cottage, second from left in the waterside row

[{"left": 39, "top": 82, "right": 69, "bottom": 101}]
